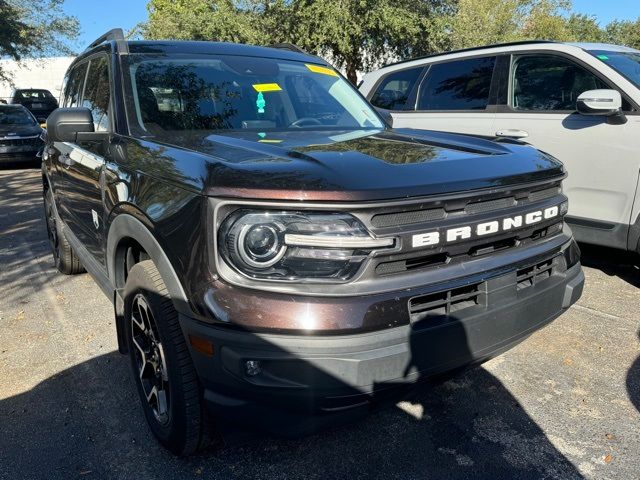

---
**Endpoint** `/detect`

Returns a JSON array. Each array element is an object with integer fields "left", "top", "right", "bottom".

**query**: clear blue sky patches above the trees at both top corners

[{"left": 63, "top": 0, "right": 640, "bottom": 50}]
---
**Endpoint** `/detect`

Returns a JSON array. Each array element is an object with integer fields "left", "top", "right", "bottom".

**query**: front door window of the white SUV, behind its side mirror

[{"left": 510, "top": 55, "right": 609, "bottom": 111}]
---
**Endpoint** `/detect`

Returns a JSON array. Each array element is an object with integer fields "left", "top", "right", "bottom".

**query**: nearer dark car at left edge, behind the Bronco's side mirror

[{"left": 0, "top": 104, "right": 44, "bottom": 165}]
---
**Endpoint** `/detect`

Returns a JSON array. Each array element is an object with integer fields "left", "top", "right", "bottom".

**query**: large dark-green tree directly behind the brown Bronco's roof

[{"left": 143, "top": 0, "right": 451, "bottom": 83}]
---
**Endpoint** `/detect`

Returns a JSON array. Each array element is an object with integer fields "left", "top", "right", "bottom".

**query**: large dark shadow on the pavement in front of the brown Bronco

[{"left": 0, "top": 329, "right": 581, "bottom": 480}]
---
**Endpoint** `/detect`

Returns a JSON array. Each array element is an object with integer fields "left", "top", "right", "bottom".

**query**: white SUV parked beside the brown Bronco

[{"left": 360, "top": 42, "right": 640, "bottom": 253}]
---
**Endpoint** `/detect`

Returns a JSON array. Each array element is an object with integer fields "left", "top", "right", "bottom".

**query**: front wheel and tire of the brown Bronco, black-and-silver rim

[{"left": 124, "top": 260, "right": 204, "bottom": 456}]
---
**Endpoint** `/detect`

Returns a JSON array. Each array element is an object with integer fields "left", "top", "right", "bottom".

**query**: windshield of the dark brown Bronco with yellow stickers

[{"left": 128, "top": 55, "right": 383, "bottom": 137}]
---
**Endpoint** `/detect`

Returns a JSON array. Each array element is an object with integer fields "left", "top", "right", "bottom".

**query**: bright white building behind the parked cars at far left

[{"left": 0, "top": 57, "right": 74, "bottom": 102}]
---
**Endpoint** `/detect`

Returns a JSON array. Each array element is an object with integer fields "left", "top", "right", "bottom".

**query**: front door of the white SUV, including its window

[{"left": 495, "top": 53, "right": 640, "bottom": 248}]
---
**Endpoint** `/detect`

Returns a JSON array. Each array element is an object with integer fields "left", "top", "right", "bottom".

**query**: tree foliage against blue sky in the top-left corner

[{"left": 0, "top": 0, "right": 78, "bottom": 80}]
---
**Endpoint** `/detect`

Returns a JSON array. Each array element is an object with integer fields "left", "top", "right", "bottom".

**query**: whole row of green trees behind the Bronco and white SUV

[{"left": 145, "top": 0, "right": 640, "bottom": 82}]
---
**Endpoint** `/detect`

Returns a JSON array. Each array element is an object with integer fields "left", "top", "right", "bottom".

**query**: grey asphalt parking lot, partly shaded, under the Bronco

[{"left": 0, "top": 169, "right": 640, "bottom": 480}]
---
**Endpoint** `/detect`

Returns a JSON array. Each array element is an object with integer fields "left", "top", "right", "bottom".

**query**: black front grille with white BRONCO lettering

[{"left": 361, "top": 180, "right": 566, "bottom": 276}]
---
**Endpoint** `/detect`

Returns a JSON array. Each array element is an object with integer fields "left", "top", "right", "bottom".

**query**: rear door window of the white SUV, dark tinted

[{"left": 418, "top": 57, "right": 496, "bottom": 110}]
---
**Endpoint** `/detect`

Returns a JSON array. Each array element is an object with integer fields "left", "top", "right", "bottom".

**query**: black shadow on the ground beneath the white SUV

[{"left": 580, "top": 243, "right": 640, "bottom": 287}]
